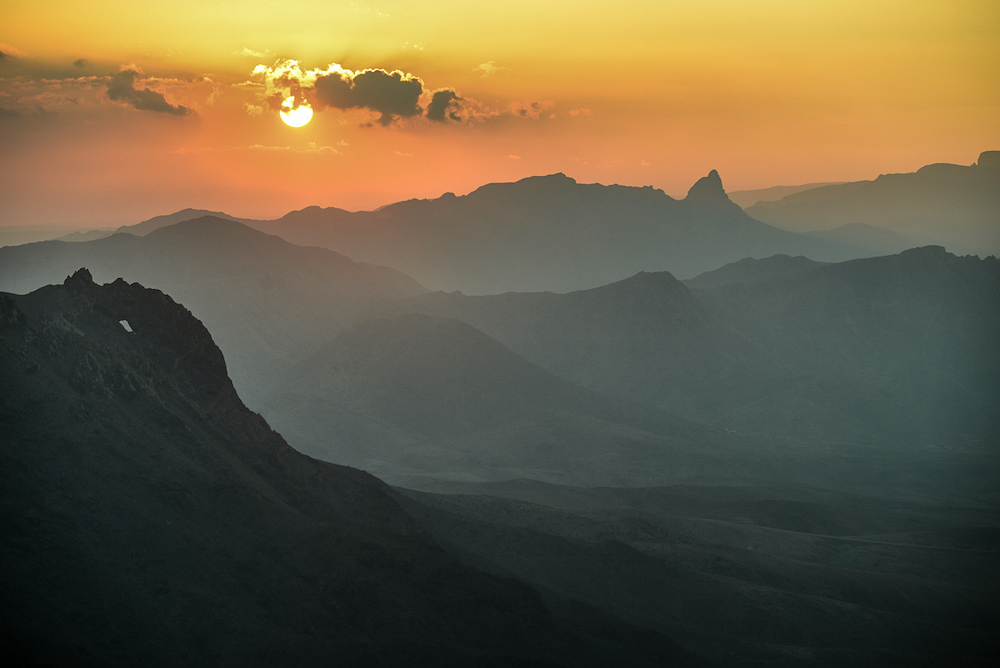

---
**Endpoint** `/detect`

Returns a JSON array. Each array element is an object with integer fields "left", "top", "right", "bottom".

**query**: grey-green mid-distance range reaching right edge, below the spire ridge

[{"left": 378, "top": 247, "right": 1000, "bottom": 442}]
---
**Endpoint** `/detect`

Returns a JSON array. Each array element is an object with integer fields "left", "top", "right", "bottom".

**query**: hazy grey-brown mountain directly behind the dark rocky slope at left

[{"left": 0, "top": 216, "right": 424, "bottom": 405}]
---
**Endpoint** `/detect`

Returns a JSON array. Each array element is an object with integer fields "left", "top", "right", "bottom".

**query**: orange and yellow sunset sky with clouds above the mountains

[{"left": 0, "top": 0, "right": 1000, "bottom": 226}]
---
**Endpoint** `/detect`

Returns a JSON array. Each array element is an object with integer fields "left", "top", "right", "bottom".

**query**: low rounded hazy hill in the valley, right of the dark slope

[{"left": 263, "top": 314, "right": 718, "bottom": 484}]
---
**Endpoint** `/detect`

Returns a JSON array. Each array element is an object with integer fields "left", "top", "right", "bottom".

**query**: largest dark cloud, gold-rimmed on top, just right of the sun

[{"left": 314, "top": 69, "right": 424, "bottom": 125}]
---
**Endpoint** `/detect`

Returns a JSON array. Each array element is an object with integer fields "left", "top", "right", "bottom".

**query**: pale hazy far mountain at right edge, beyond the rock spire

[{"left": 746, "top": 151, "right": 1000, "bottom": 259}]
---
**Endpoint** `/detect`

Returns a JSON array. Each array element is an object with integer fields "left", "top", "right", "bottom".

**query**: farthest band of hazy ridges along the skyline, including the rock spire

[{"left": 11, "top": 151, "right": 1000, "bottom": 294}]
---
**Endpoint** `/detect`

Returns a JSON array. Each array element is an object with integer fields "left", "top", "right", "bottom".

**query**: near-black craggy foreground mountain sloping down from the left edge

[{"left": 0, "top": 270, "right": 700, "bottom": 666}]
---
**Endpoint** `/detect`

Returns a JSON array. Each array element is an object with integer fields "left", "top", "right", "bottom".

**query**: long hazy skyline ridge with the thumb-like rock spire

[{"left": 244, "top": 171, "right": 870, "bottom": 294}]
